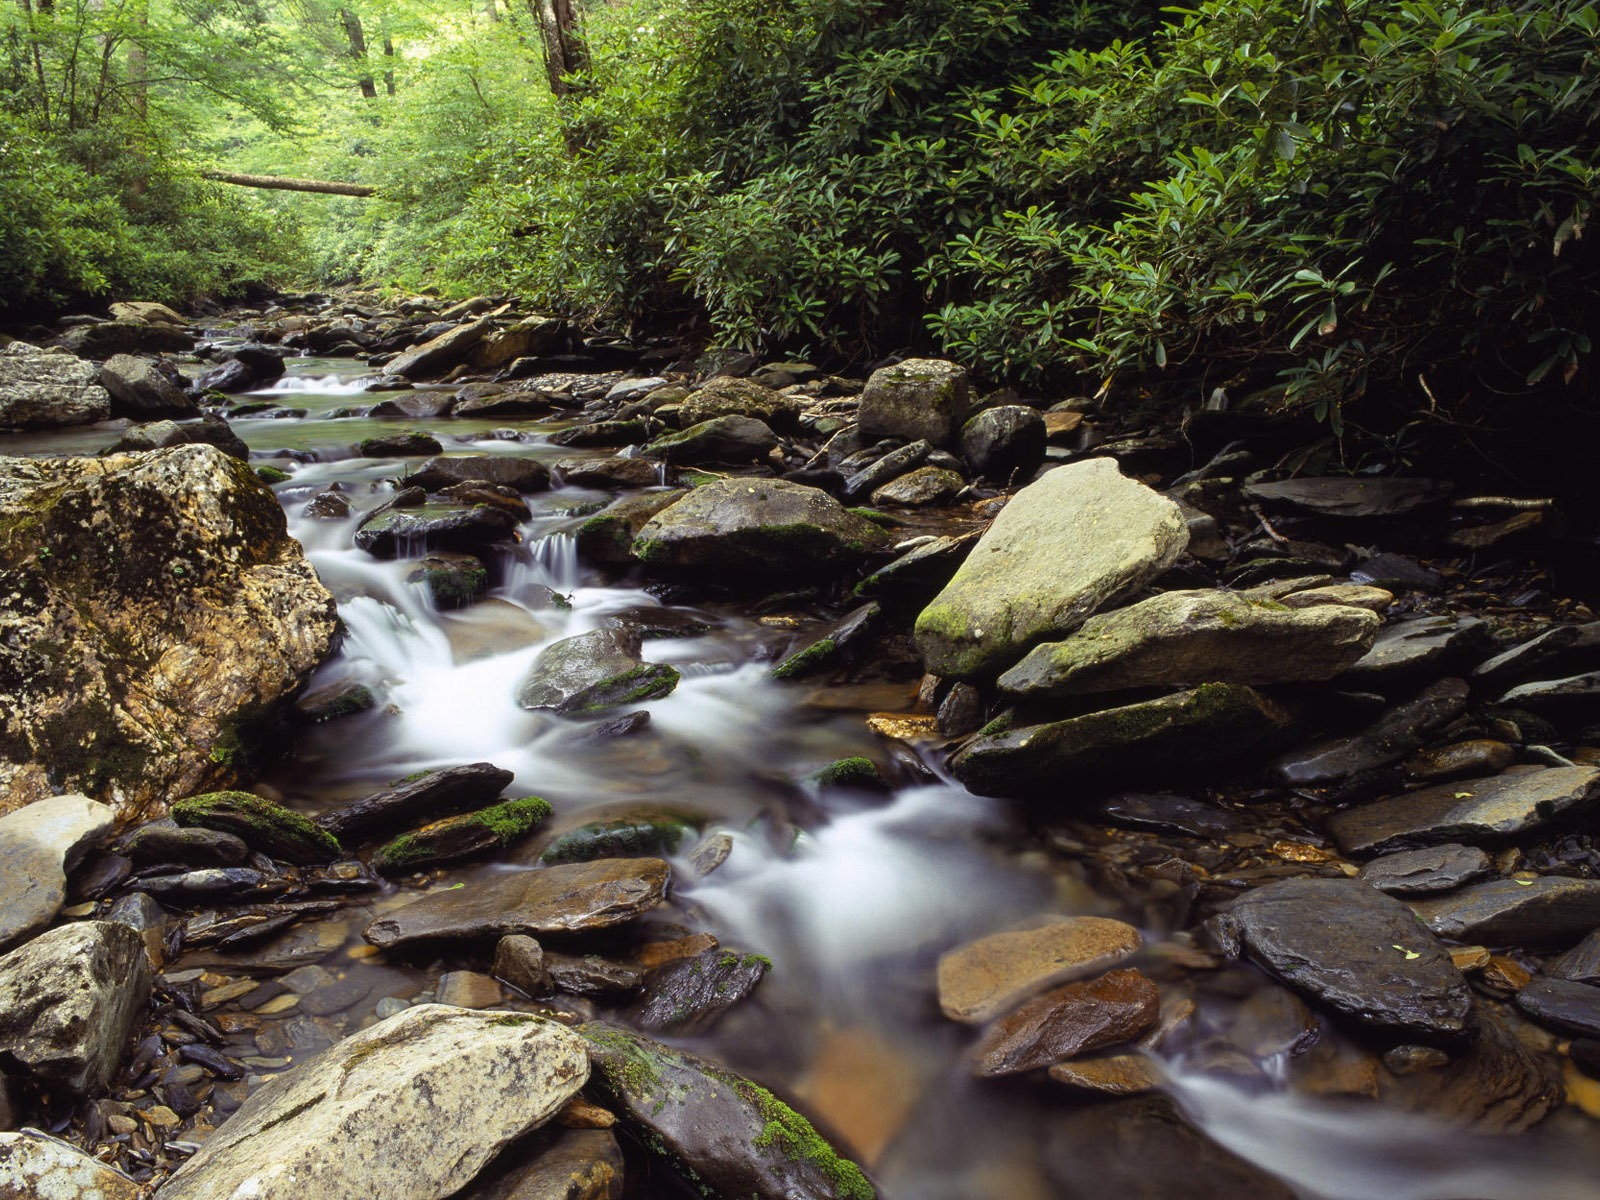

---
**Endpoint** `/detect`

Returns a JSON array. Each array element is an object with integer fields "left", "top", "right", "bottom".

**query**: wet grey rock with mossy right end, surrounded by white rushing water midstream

[{"left": 517, "top": 629, "right": 678, "bottom": 717}]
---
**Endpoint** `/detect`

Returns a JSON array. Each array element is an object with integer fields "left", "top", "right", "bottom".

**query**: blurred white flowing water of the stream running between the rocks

[{"left": 21, "top": 352, "right": 1600, "bottom": 1200}]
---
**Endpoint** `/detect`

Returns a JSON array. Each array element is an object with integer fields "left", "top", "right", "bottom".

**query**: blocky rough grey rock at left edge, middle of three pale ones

[{"left": 0, "top": 922, "right": 150, "bottom": 1096}]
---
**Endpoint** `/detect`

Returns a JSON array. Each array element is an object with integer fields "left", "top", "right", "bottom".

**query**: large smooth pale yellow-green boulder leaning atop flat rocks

[{"left": 917, "top": 458, "right": 1189, "bottom": 678}]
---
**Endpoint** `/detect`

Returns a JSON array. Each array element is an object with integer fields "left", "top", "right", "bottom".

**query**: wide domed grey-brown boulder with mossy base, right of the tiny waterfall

[{"left": 632, "top": 478, "right": 890, "bottom": 579}]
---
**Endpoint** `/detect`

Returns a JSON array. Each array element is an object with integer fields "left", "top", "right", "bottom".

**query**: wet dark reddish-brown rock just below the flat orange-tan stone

[{"left": 973, "top": 970, "right": 1162, "bottom": 1077}]
